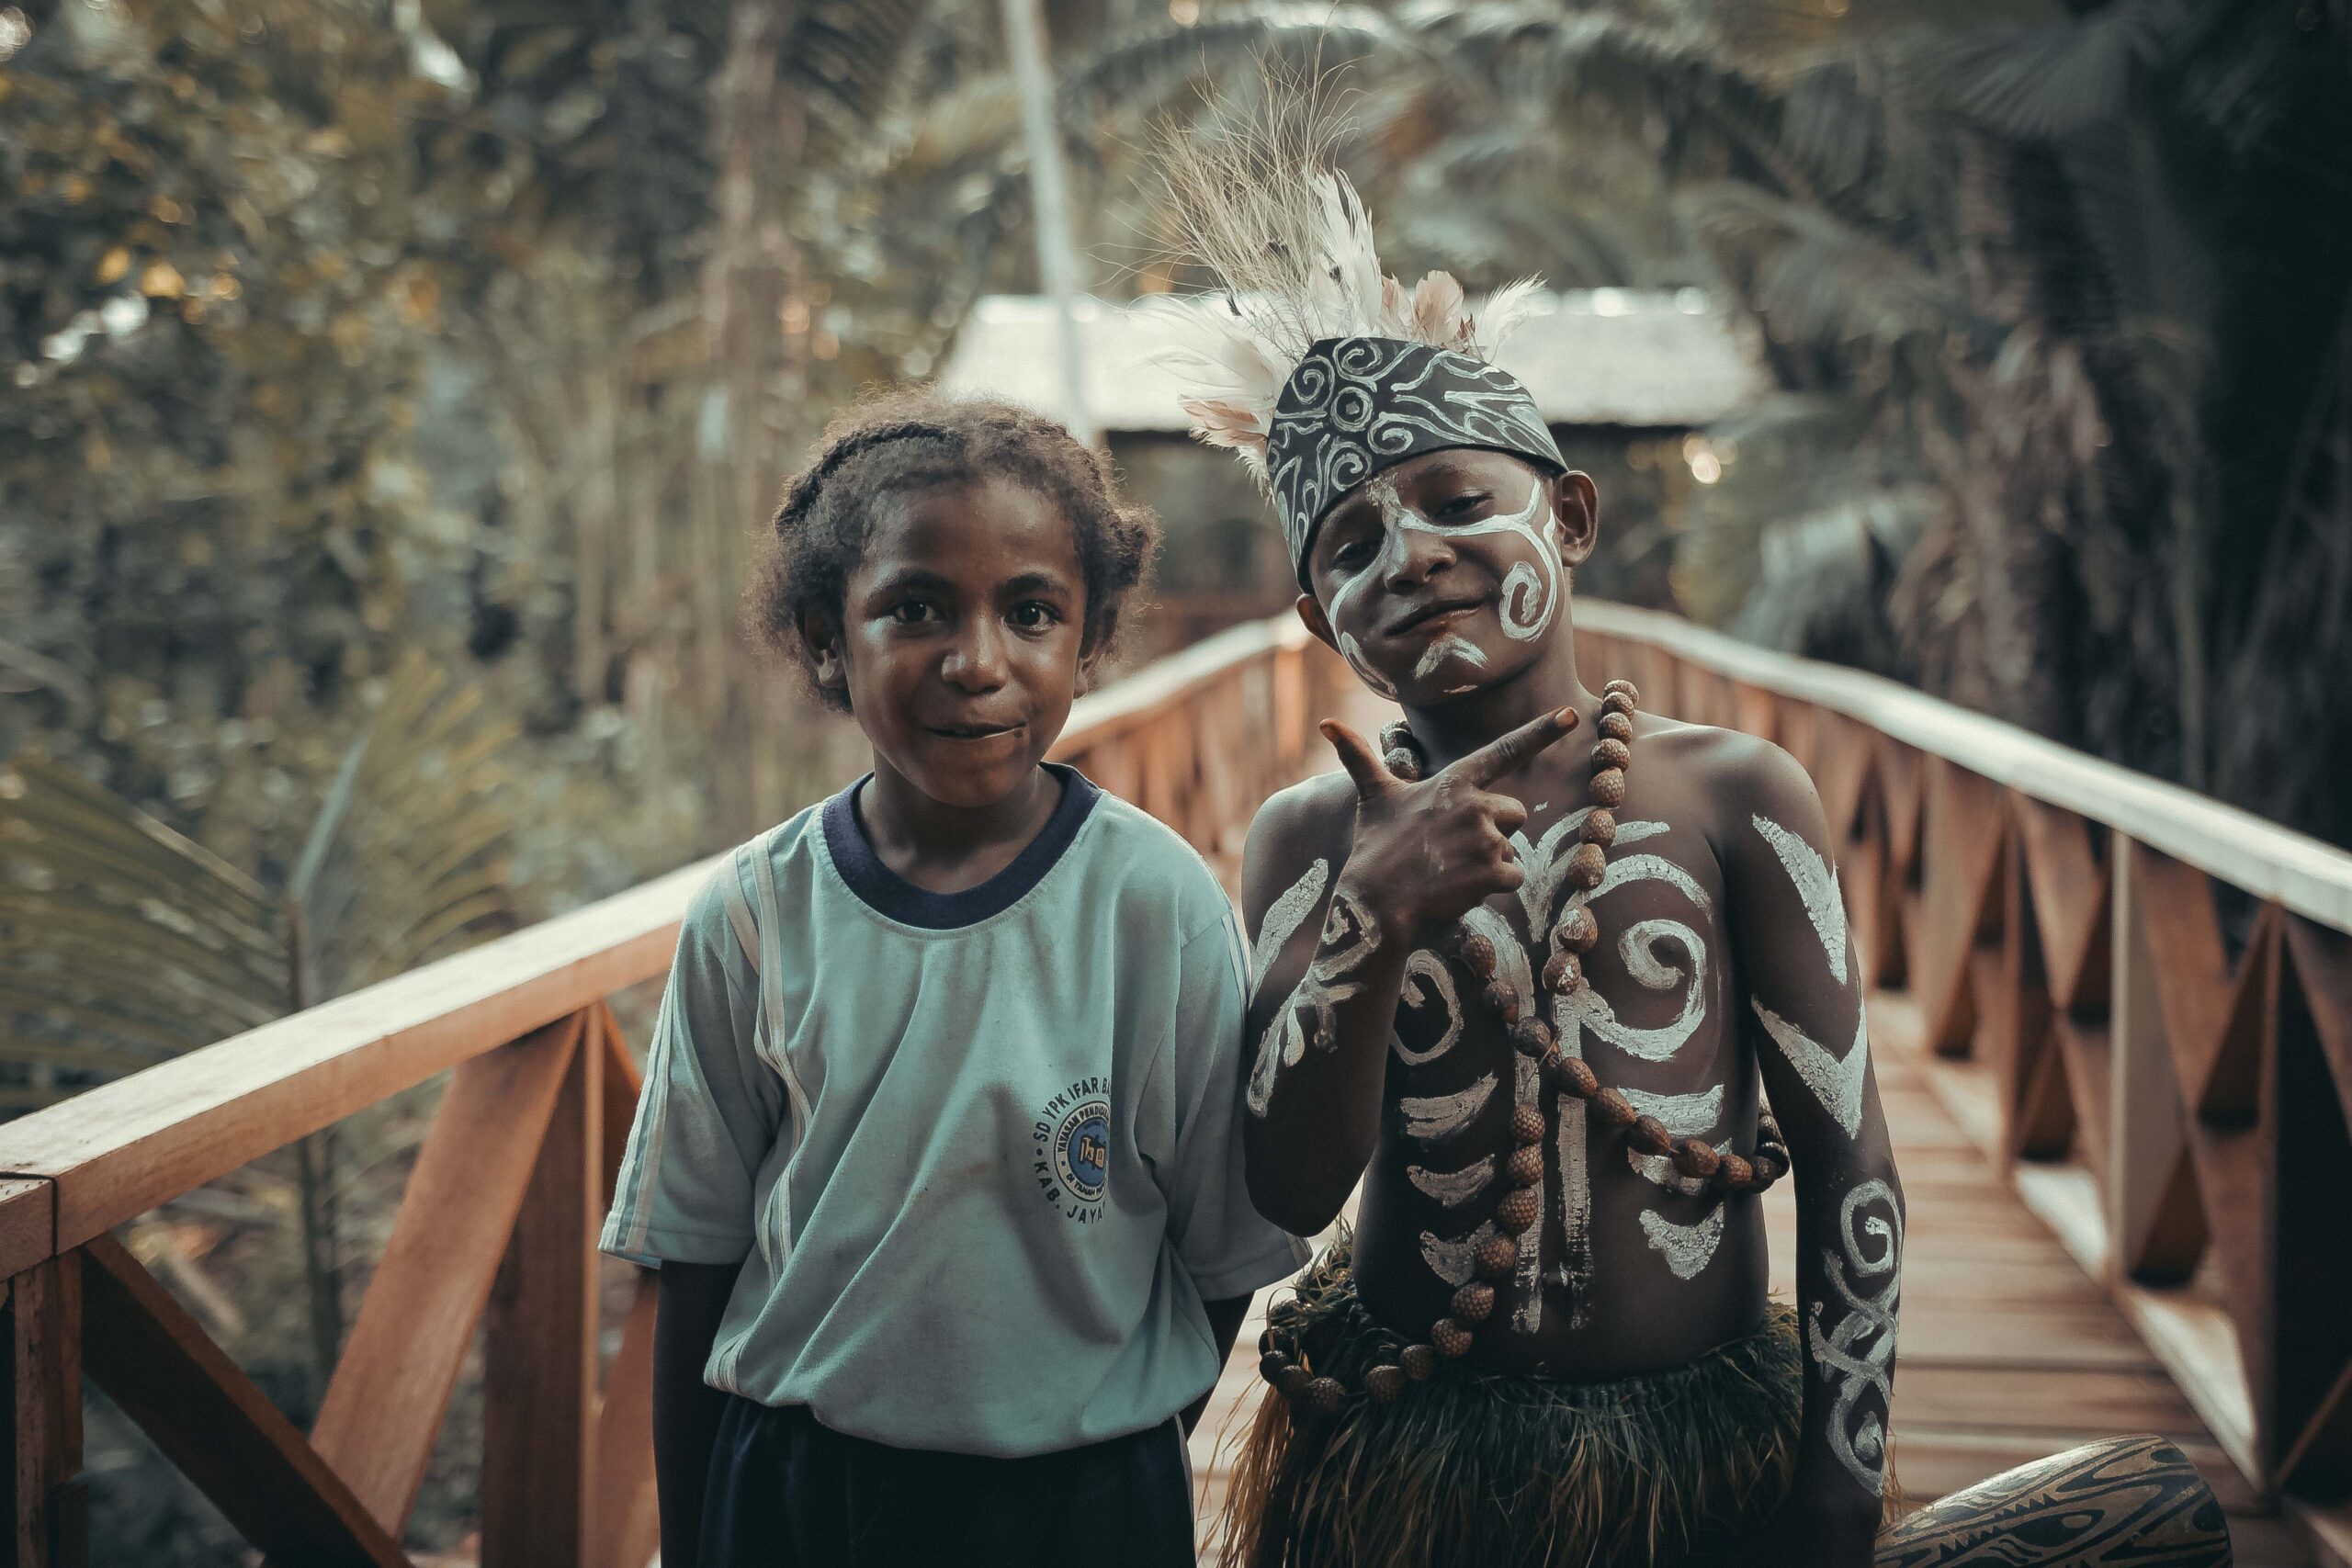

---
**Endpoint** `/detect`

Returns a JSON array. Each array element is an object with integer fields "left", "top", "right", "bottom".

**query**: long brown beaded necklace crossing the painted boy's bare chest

[{"left": 1259, "top": 680, "right": 1788, "bottom": 1416}]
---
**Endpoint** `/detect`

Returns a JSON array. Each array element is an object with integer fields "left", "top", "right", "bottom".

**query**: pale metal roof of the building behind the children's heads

[{"left": 938, "top": 289, "right": 1771, "bottom": 433}]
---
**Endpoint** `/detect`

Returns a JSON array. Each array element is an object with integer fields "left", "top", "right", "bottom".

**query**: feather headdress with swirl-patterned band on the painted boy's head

[{"left": 1138, "top": 92, "right": 1566, "bottom": 576}]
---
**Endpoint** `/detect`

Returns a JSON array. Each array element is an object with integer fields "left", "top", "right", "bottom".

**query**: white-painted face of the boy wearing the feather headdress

[{"left": 1298, "top": 449, "right": 1595, "bottom": 707}]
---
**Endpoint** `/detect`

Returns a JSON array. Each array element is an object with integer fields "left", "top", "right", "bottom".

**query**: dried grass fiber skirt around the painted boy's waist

[{"left": 1221, "top": 1235, "right": 1804, "bottom": 1568}]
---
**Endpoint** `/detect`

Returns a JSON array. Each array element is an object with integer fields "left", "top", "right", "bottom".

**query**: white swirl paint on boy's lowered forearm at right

[{"left": 1806, "top": 1178, "right": 1903, "bottom": 1493}]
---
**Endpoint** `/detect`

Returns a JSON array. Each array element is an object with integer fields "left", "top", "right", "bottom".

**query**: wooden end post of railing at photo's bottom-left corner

[{"left": 0, "top": 1253, "right": 89, "bottom": 1568}]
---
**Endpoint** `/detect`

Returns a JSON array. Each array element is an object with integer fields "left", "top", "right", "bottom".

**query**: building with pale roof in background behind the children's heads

[{"left": 938, "top": 289, "right": 1771, "bottom": 656}]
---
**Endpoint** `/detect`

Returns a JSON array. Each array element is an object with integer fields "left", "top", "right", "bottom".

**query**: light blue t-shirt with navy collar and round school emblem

[{"left": 602, "top": 766, "right": 1306, "bottom": 1458}]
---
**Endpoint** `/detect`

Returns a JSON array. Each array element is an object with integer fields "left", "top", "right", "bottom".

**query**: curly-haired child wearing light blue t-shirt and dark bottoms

[{"left": 602, "top": 395, "right": 1306, "bottom": 1568}]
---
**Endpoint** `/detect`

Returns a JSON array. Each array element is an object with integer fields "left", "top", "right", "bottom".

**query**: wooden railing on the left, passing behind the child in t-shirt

[{"left": 0, "top": 623, "right": 1352, "bottom": 1568}]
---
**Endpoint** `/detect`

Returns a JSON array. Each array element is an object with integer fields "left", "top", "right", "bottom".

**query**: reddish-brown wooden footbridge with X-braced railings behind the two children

[{"left": 0, "top": 604, "right": 2352, "bottom": 1568}]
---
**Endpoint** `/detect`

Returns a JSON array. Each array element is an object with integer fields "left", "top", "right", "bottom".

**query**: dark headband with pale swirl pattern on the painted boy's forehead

[{"left": 1265, "top": 339, "right": 1569, "bottom": 588}]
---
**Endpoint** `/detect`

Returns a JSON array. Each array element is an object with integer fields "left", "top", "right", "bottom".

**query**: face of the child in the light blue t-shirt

[{"left": 816, "top": 478, "right": 1089, "bottom": 807}]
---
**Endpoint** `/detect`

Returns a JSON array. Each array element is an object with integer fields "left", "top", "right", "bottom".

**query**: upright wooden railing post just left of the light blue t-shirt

[{"left": 482, "top": 1010, "right": 605, "bottom": 1568}]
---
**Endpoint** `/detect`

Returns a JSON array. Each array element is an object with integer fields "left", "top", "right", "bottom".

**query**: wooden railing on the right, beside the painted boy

[{"left": 1578, "top": 604, "right": 2352, "bottom": 1500}]
